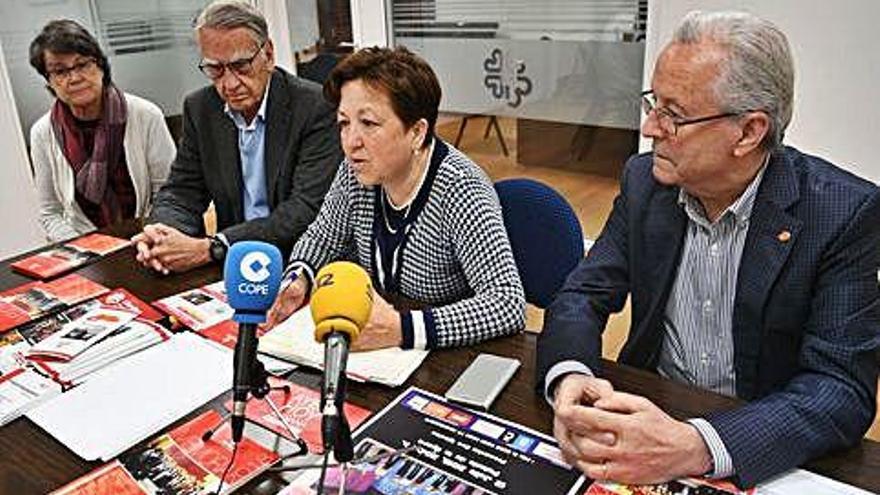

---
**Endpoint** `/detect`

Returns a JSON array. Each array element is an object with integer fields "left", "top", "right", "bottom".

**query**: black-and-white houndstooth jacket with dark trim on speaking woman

[{"left": 287, "top": 139, "right": 525, "bottom": 349}]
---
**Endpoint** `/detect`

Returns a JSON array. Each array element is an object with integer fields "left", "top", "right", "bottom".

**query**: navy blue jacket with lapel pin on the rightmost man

[{"left": 537, "top": 147, "right": 880, "bottom": 486}]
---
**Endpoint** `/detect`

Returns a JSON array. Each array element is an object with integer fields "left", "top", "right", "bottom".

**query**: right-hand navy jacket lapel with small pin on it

[{"left": 733, "top": 150, "right": 803, "bottom": 399}]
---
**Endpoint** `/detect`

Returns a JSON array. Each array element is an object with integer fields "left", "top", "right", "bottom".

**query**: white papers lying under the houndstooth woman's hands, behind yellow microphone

[{"left": 258, "top": 306, "right": 428, "bottom": 387}]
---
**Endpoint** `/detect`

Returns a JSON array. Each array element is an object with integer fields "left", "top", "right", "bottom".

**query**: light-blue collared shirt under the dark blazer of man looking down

[{"left": 224, "top": 80, "right": 271, "bottom": 221}]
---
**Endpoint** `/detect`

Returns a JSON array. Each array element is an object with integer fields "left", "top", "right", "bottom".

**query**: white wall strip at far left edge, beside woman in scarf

[{"left": 0, "top": 38, "right": 45, "bottom": 258}]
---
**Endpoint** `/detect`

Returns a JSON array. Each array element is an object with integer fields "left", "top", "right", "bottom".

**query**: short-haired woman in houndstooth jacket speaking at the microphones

[{"left": 268, "top": 48, "right": 525, "bottom": 350}]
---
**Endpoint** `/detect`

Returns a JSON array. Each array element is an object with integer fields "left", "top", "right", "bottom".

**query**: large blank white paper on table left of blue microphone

[{"left": 27, "top": 333, "right": 232, "bottom": 461}]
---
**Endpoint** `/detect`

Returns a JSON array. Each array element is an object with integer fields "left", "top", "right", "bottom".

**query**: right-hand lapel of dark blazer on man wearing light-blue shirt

[{"left": 264, "top": 69, "right": 292, "bottom": 207}]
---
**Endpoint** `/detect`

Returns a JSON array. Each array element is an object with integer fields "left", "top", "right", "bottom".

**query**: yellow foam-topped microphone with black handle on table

[{"left": 311, "top": 261, "right": 373, "bottom": 462}]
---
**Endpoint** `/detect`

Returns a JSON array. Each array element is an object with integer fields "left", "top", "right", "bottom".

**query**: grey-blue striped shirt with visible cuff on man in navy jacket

[{"left": 657, "top": 164, "right": 766, "bottom": 477}]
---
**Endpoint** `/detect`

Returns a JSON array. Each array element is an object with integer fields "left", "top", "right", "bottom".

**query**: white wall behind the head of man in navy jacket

[{"left": 643, "top": 0, "right": 880, "bottom": 182}]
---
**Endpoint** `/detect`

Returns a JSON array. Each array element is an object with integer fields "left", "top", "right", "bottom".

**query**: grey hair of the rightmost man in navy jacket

[{"left": 673, "top": 11, "right": 794, "bottom": 149}]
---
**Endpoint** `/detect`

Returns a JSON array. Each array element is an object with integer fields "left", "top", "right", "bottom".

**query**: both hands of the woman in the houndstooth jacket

[{"left": 266, "top": 277, "right": 403, "bottom": 351}]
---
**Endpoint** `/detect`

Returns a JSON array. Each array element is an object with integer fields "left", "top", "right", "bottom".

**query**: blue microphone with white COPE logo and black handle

[{"left": 223, "top": 241, "right": 284, "bottom": 443}]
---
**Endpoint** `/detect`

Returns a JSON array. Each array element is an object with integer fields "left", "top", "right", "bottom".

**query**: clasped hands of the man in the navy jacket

[{"left": 553, "top": 374, "right": 711, "bottom": 484}]
